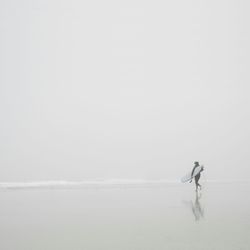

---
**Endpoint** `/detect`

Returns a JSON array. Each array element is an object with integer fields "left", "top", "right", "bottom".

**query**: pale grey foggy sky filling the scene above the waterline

[{"left": 0, "top": 0, "right": 250, "bottom": 182}]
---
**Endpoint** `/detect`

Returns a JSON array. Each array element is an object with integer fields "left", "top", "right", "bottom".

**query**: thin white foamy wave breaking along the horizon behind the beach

[{"left": 0, "top": 180, "right": 178, "bottom": 189}]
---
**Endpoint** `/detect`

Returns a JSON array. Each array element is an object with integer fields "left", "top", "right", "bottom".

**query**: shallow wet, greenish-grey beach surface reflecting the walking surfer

[{"left": 0, "top": 182, "right": 250, "bottom": 250}]
